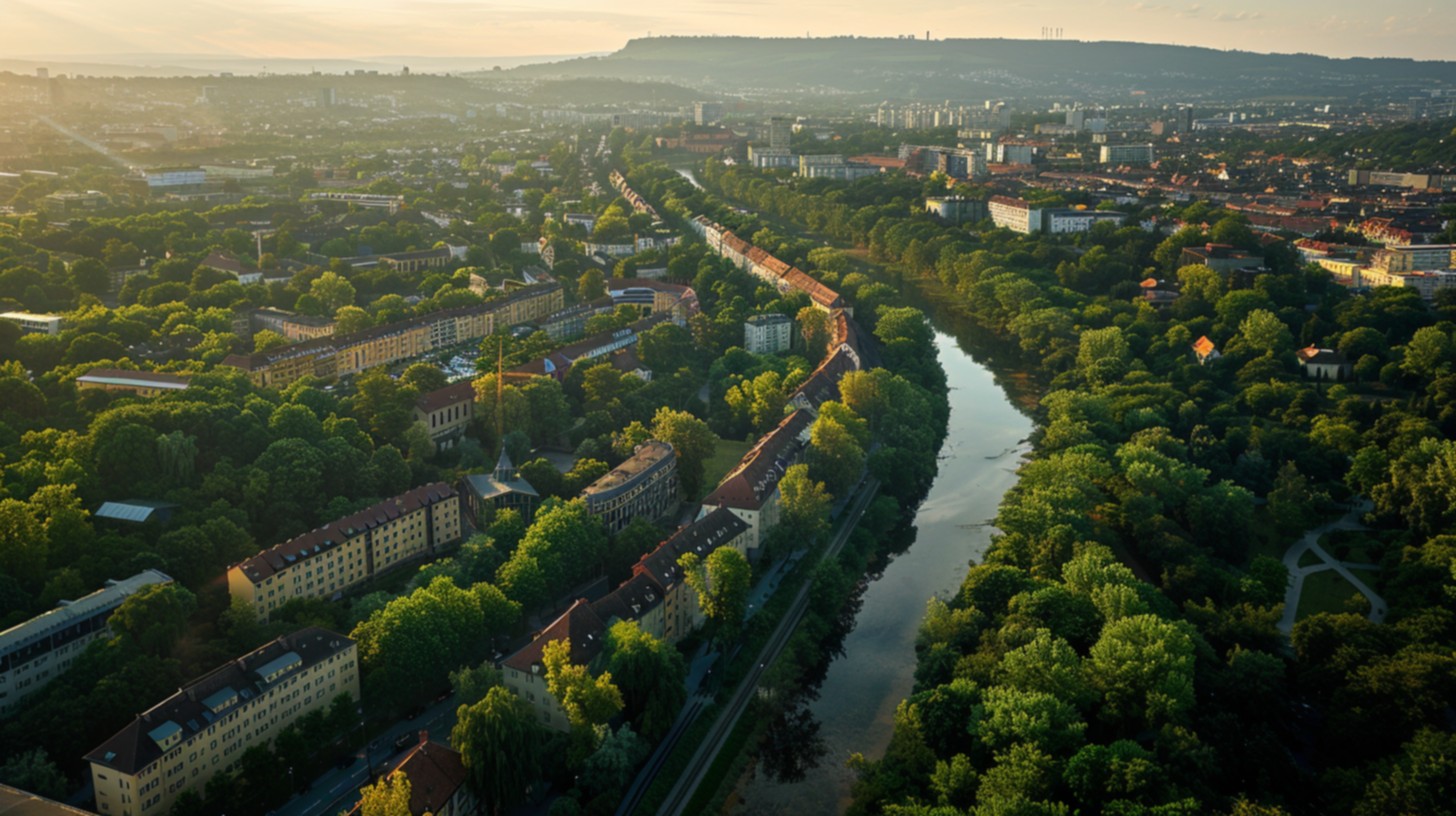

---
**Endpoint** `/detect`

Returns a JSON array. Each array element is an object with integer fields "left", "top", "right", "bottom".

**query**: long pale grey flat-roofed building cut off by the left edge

[{"left": 0, "top": 570, "right": 172, "bottom": 717}]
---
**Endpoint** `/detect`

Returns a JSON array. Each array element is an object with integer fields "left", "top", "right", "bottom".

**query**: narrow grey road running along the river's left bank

[{"left": 655, "top": 478, "right": 879, "bottom": 816}]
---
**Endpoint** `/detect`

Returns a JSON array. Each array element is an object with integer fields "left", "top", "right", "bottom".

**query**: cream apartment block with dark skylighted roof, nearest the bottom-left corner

[{"left": 86, "top": 627, "right": 360, "bottom": 816}]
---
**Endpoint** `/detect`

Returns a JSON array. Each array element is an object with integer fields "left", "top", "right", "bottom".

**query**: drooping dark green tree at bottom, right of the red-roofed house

[{"left": 450, "top": 686, "right": 543, "bottom": 816}]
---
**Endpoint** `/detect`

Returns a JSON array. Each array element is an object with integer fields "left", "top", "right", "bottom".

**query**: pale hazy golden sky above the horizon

[{"left": 0, "top": 0, "right": 1456, "bottom": 58}]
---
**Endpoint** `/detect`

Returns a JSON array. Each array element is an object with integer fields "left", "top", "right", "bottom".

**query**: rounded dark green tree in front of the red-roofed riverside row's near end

[{"left": 607, "top": 621, "right": 687, "bottom": 742}]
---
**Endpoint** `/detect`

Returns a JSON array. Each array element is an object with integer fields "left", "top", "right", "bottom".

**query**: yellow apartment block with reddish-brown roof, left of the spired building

[{"left": 227, "top": 482, "right": 462, "bottom": 621}]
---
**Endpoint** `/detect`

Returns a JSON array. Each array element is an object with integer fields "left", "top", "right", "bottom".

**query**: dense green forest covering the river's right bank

[{"left": 687, "top": 163, "right": 1456, "bottom": 816}]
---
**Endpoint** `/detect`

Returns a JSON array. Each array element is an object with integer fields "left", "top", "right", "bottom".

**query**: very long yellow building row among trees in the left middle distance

[{"left": 223, "top": 284, "right": 565, "bottom": 388}]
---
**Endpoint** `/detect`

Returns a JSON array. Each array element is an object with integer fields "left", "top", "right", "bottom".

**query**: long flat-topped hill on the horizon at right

[{"left": 513, "top": 36, "right": 1456, "bottom": 99}]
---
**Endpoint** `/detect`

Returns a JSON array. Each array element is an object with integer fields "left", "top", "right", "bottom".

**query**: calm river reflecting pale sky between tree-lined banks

[{"left": 729, "top": 319, "right": 1032, "bottom": 816}]
